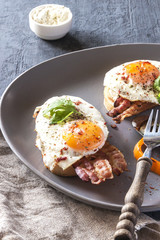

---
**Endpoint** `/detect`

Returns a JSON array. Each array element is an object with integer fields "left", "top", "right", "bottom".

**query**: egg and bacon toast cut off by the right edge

[{"left": 104, "top": 60, "right": 160, "bottom": 123}]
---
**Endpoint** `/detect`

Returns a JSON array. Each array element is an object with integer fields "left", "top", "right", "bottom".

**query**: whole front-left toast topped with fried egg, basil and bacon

[{"left": 34, "top": 96, "right": 127, "bottom": 184}]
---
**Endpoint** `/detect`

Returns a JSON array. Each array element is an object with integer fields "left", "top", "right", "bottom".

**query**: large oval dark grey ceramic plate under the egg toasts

[{"left": 1, "top": 44, "right": 160, "bottom": 211}]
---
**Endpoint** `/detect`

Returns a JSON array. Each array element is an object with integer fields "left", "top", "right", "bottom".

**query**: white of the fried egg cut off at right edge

[{"left": 104, "top": 60, "right": 160, "bottom": 104}]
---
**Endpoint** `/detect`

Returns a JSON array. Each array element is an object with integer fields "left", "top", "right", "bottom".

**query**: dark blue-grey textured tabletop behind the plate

[{"left": 0, "top": 0, "right": 160, "bottom": 221}]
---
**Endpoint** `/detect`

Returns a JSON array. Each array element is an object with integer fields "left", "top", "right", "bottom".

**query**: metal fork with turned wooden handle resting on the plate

[{"left": 114, "top": 110, "right": 160, "bottom": 240}]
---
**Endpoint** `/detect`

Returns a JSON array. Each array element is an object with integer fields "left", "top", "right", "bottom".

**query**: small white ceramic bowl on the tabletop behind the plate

[{"left": 29, "top": 4, "right": 72, "bottom": 40}]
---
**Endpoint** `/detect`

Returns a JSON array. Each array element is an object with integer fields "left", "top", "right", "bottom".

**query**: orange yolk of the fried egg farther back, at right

[{"left": 124, "top": 61, "right": 160, "bottom": 86}]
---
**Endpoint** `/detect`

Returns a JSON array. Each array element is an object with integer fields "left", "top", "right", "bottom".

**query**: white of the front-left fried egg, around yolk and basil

[{"left": 35, "top": 96, "right": 108, "bottom": 171}]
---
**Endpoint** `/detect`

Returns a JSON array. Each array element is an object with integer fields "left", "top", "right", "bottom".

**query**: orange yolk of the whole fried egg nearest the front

[{"left": 63, "top": 120, "right": 104, "bottom": 152}]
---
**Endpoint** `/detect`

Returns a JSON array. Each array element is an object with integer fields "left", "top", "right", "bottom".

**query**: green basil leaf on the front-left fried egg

[{"left": 43, "top": 98, "right": 83, "bottom": 124}]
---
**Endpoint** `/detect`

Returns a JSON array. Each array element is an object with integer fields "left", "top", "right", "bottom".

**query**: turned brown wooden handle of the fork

[{"left": 114, "top": 157, "right": 152, "bottom": 240}]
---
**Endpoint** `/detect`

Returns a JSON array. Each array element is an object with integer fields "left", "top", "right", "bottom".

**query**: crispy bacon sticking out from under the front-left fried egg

[{"left": 74, "top": 142, "right": 127, "bottom": 184}]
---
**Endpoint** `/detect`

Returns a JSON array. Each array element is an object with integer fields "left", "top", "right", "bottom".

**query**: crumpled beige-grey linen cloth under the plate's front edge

[{"left": 0, "top": 133, "right": 160, "bottom": 240}]
